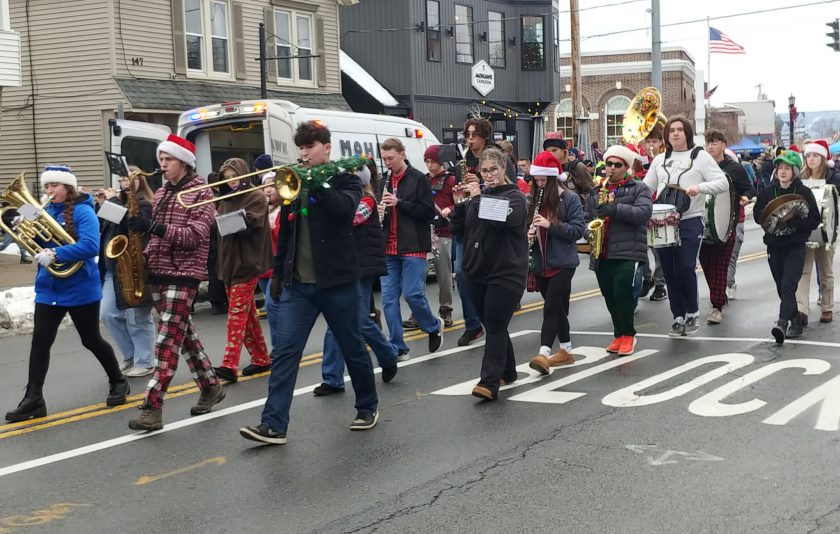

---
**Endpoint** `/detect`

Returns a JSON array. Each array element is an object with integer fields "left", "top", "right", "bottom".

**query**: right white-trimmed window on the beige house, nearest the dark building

[{"left": 274, "top": 9, "right": 315, "bottom": 86}]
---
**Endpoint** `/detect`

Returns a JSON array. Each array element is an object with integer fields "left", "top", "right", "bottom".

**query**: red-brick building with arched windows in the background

[{"left": 546, "top": 48, "right": 702, "bottom": 151}]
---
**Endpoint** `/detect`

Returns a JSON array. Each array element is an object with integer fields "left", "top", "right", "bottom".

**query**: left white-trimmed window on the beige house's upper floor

[{"left": 184, "top": 0, "right": 232, "bottom": 78}]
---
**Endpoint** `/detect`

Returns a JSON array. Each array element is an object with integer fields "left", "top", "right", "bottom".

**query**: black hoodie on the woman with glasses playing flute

[{"left": 450, "top": 184, "right": 528, "bottom": 293}]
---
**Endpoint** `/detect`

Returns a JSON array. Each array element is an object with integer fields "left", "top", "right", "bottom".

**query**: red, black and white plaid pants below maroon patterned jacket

[{"left": 146, "top": 284, "right": 219, "bottom": 408}]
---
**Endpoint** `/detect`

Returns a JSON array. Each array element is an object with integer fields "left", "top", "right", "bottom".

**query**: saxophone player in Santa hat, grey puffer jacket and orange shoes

[{"left": 589, "top": 145, "right": 652, "bottom": 356}]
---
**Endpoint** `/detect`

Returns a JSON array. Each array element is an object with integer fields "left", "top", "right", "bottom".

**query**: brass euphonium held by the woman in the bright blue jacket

[{"left": 0, "top": 173, "right": 84, "bottom": 278}]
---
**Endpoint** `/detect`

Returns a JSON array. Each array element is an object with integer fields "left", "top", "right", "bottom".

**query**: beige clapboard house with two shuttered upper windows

[{"left": 0, "top": 0, "right": 349, "bottom": 191}]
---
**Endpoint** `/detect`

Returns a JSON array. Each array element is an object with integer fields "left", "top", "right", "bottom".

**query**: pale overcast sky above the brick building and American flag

[{"left": 558, "top": 0, "right": 840, "bottom": 113}]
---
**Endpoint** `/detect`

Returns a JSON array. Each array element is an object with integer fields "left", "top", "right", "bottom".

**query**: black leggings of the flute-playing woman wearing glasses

[{"left": 467, "top": 282, "right": 522, "bottom": 391}]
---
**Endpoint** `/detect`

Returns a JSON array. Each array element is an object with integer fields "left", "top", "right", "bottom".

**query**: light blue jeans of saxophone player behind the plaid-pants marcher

[{"left": 99, "top": 271, "right": 155, "bottom": 367}]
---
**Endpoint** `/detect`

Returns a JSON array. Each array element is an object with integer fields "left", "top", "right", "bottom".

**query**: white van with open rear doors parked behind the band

[{"left": 110, "top": 100, "right": 439, "bottom": 184}]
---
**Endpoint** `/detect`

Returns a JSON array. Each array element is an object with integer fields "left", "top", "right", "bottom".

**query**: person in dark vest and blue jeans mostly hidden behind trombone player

[{"left": 312, "top": 161, "right": 398, "bottom": 397}]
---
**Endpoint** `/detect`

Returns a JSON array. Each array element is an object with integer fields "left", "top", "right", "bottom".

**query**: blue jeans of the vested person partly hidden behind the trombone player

[{"left": 321, "top": 276, "right": 397, "bottom": 388}]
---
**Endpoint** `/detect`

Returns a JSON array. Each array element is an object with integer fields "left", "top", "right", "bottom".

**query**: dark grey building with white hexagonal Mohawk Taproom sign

[{"left": 341, "top": 0, "right": 561, "bottom": 159}]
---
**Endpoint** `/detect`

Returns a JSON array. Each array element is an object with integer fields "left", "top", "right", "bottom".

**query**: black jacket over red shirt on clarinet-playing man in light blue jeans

[{"left": 382, "top": 167, "right": 437, "bottom": 254}]
